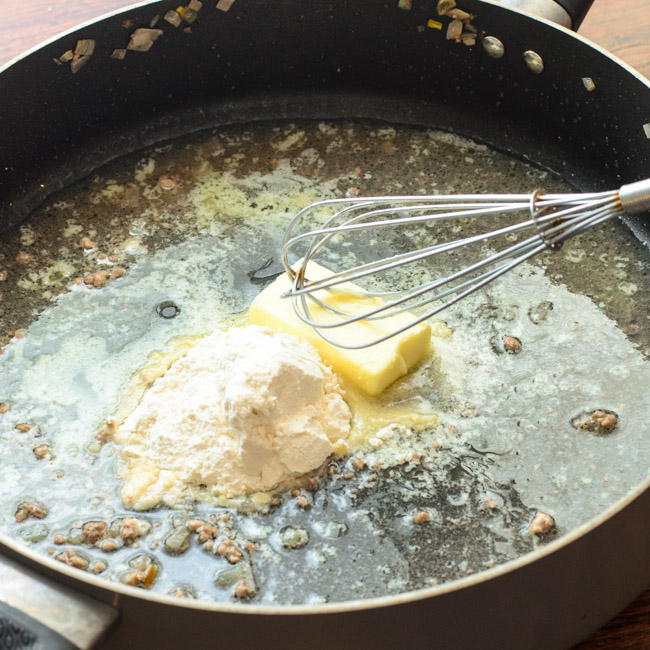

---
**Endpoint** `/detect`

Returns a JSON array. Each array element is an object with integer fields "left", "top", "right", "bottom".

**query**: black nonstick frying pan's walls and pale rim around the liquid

[{"left": 0, "top": 0, "right": 650, "bottom": 648}]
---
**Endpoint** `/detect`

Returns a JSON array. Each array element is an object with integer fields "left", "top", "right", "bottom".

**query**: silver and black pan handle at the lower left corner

[{"left": 0, "top": 554, "right": 118, "bottom": 650}]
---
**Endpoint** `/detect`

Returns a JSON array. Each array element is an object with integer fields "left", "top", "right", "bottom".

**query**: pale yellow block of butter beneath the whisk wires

[{"left": 250, "top": 262, "right": 431, "bottom": 395}]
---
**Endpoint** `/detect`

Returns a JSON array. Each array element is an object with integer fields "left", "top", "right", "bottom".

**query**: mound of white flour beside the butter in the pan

[{"left": 117, "top": 326, "right": 351, "bottom": 509}]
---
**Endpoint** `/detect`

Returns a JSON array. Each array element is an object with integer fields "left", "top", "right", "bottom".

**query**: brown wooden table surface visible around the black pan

[{"left": 0, "top": 0, "right": 650, "bottom": 650}]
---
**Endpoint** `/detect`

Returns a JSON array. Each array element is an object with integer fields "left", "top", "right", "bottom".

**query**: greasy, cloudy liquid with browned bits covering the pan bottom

[{"left": 0, "top": 123, "right": 650, "bottom": 604}]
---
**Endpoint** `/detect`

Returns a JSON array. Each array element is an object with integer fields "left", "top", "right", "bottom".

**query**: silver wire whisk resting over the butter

[{"left": 281, "top": 179, "right": 650, "bottom": 349}]
